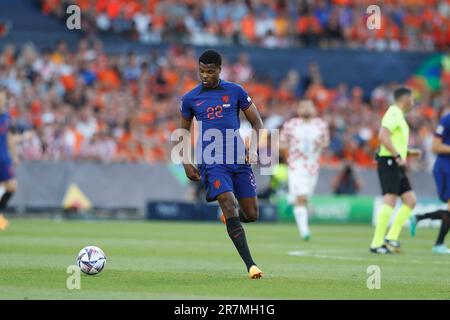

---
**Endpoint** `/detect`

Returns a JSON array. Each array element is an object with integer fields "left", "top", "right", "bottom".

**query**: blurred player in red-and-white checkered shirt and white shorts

[{"left": 280, "top": 100, "right": 329, "bottom": 240}]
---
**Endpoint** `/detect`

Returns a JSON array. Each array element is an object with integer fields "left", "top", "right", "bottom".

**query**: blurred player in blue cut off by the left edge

[{"left": 0, "top": 89, "right": 18, "bottom": 230}]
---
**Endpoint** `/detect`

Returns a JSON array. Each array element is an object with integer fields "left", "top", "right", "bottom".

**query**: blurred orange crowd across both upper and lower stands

[{"left": 0, "top": 0, "right": 450, "bottom": 169}]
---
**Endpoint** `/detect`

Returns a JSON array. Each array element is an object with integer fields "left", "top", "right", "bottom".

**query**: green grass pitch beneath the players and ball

[{"left": 0, "top": 218, "right": 450, "bottom": 300}]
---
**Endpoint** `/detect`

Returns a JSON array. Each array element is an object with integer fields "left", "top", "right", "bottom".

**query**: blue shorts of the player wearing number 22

[{"left": 198, "top": 164, "right": 256, "bottom": 202}]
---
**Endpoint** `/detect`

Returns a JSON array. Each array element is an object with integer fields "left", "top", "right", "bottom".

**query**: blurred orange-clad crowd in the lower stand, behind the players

[{"left": 0, "top": 40, "right": 450, "bottom": 167}]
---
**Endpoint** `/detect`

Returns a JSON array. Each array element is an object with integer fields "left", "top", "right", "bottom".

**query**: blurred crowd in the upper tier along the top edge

[{"left": 41, "top": 0, "right": 450, "bottom": 50}]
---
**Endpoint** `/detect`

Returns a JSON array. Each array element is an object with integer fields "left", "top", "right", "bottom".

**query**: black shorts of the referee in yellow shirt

[{"left": 377, "top": 157, "right": 412, "bottom": 196}]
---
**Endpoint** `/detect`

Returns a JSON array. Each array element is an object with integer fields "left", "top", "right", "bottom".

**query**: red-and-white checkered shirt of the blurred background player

[{"left": 280, "top": 117, "right": 329, "bottom": 174}]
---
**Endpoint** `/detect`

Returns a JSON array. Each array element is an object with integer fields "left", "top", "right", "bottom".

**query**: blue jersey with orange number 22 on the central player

[{"left": 180, "top": 80, "right": 252, "bottom": 165}]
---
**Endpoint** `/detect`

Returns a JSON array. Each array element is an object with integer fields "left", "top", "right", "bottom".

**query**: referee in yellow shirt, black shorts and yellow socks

[{"left": 370, "top": 87, "right": 421, "bottom": 254}]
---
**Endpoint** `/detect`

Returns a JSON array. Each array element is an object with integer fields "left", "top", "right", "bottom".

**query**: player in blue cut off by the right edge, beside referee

[{"left": 410, "top": 106, "right": 450, "bottom": 254}]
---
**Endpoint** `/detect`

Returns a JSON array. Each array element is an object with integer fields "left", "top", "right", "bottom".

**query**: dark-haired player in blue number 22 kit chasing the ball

[{"left": 180, "top": 50, "right": 263, "bottom": 279}]
